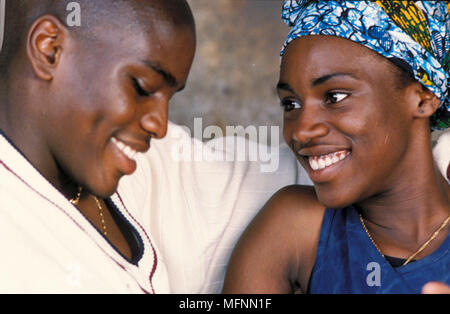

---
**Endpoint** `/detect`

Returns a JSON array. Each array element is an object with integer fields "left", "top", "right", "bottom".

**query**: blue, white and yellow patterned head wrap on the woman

[{"left": 281, "top": 0, "right": 450, "bottom": 130}]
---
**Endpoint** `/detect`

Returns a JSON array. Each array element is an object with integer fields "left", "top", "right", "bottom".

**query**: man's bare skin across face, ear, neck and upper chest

[{"left": 0, "top": 0, "right": 195, "bottom": 258}]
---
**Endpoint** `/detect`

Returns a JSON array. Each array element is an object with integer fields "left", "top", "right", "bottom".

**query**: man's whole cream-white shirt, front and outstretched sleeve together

[{"left": 0, "top": 124, "right": 309, "bottom": 293}]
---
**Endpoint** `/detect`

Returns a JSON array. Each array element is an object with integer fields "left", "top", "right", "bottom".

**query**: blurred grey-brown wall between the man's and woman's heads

[{"left": 170, "top": 0, "right": 288, "bottom": 140}]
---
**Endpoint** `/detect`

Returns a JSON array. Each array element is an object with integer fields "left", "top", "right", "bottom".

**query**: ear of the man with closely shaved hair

[{"left": 27, "top": 15, "right": 67, "bottom": 81}]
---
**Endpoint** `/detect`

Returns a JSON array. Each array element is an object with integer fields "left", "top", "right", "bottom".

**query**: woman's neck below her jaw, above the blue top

[{"left": 356, "top": 134, "right": 450, "bottom": 257}]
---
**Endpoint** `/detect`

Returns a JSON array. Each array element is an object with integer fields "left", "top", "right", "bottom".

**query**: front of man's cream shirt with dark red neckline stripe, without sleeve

[{"left": 0, "top": 131, "right": 170, "bottom": 293}]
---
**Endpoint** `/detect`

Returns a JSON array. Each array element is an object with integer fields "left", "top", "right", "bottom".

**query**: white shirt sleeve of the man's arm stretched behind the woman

[{"left": 119, "top": 124, "right": 311, "bottom": 293}]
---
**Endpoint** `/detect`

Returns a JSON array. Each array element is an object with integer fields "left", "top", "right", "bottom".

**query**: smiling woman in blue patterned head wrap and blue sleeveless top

[{"left": 224, "top": 0, "right": 450, "bottom": 293}]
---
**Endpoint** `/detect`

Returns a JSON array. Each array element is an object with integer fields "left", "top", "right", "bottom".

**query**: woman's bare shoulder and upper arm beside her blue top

[{"left": 223, "top": 186, "right": 324, "bottom": 294}]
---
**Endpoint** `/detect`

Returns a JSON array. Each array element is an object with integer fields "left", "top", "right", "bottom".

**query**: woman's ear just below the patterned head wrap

[{"left": 408, "top": 82, "right": 441, "bottom": 119}]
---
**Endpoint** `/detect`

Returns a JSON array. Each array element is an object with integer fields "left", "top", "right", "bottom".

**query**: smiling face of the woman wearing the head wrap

[{"left": 278, "top": 36, "right": 416, "bottom": 208}]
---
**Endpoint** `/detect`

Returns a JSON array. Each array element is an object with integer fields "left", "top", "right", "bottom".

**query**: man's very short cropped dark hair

[{"left": 0, "top": 0, "right": 195, "bottom": 78}]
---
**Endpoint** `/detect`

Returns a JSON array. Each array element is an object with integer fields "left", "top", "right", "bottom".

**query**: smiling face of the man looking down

[{"left": 42, "top": 16, "right": 195, "bottom": 197}]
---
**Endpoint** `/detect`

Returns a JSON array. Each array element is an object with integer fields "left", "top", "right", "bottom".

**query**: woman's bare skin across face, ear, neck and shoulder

[{"left": 224, "top": 36, "right": 450, "bottom": 293}]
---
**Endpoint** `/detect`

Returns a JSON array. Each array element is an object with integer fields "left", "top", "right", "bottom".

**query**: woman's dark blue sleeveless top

[{"left": 308, "top": 206, "right": 450, "bottom": 294}]
